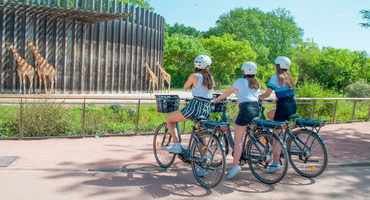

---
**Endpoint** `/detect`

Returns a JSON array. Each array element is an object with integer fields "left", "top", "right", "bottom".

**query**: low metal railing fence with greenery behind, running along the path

[{"left": 0, "top": 95, "right": 370, "bottom": 139}]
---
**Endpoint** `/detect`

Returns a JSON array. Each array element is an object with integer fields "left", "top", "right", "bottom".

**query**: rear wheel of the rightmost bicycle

[{"left": 286, "top": 129, "right": 328, "bottom": 178}]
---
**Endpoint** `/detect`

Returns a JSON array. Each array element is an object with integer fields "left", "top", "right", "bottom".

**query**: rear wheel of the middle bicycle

[{"left": 245, "top": 131, "right": 288, "bottom": 184}]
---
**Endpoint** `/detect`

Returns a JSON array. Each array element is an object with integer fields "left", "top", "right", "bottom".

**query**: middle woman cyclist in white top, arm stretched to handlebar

[{"left": 211, "top": 62, "right": 260, "bottom": 179}]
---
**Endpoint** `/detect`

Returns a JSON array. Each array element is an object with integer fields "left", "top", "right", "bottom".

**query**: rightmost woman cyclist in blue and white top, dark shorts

[{"left": 259, "top": 56, "right": 297, "bottom": 172}]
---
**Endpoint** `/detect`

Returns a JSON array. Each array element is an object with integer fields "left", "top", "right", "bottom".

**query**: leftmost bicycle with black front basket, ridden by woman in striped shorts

[{"left": 153, "top": 95, "right": 226, "bottom": 188}]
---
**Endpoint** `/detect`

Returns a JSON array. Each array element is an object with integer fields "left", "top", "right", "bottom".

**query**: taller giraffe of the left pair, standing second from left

[{"left": 27, "top": 40, "right": 56, "bottom": 94}]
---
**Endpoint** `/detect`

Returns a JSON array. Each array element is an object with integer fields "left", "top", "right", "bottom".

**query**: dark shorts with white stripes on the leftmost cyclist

[{"left": 180, "top": 97, "right": 211, "bottom": 119}]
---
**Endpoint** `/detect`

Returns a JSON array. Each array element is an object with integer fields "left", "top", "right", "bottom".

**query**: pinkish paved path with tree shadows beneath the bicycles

[{"left": 0, "top": 122, "right": 370, "bottom": 200}]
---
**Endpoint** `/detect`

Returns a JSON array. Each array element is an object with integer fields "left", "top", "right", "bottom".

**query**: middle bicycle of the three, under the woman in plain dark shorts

[{"left": 205, "top": 95, "right": 288, "bottom": 184}]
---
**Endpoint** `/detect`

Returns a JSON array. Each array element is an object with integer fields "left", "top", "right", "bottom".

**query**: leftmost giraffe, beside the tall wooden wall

[{"left": 7, "top": 42, "right": 35, "bottom": 94}]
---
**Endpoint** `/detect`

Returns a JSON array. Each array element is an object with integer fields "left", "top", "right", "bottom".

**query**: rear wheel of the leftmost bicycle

[{"left": 190, "top": 133, "right": 226, "bottom": 188}]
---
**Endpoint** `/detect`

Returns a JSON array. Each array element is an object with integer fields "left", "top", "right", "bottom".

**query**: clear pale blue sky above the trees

[{"left": 149, "top": 0, "right": 370, "bottom": 54}]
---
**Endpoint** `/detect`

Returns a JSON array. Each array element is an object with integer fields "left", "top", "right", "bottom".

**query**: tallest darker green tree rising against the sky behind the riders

[{"left": 205, "top": 8, "right": 303, "bottom": 66}]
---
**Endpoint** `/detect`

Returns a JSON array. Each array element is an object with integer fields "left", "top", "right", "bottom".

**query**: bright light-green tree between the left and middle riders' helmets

[{"left": 202, "top": 34, "right": 257, "bottom": 85}]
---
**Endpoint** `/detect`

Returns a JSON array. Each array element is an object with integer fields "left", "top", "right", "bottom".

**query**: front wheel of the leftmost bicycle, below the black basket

[{"left": 153, "top": 123, "right": 176, "bottom": 168}]
